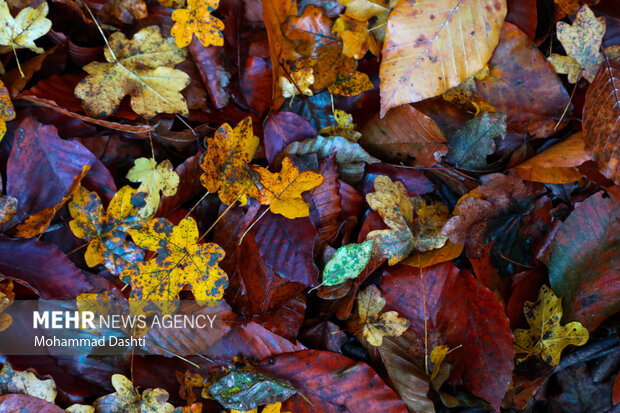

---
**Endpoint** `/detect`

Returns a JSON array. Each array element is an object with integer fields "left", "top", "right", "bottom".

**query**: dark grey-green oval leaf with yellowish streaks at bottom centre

[{"left": 203, "top": 371, "right": 297, "bottom": 411}]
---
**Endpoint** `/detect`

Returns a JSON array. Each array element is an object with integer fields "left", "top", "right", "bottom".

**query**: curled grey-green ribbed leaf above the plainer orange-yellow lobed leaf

[{"left": 280, "top": 135, "right": 379, "bottom": 183}]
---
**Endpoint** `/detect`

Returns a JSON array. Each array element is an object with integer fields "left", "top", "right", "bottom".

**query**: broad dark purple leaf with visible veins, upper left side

[{"left": 7, "top": 118, "right": 95, "bottom": 219}]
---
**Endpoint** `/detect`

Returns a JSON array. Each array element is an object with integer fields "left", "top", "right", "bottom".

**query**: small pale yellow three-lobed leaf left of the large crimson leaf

[{"left": 357, "top": 285, "right": 409, "bottom": 347}]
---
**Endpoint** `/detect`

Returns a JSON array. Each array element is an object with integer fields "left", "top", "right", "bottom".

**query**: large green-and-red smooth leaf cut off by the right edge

[{"left": 546, "top": 187, "right": 620, "bottom": 331}]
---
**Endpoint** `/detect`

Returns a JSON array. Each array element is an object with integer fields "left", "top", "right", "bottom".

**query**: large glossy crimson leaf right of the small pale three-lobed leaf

[{"left": 380, "top": 262, "right": 515, "bottom": 411}]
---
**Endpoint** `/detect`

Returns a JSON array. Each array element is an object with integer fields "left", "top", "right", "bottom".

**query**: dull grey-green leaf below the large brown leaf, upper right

[{"left": 446, "top": 113, "right": 506, "bottom": 170}]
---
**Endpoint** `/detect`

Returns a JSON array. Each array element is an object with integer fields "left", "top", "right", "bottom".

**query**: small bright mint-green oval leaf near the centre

[{"left": 323, "top": 240, "right": 373, "bottom": 285}]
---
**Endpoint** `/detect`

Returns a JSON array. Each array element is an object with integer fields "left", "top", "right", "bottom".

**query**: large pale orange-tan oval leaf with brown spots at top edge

[{"left": 379, "top": 0, "right": 507, "bottom": 117}]
